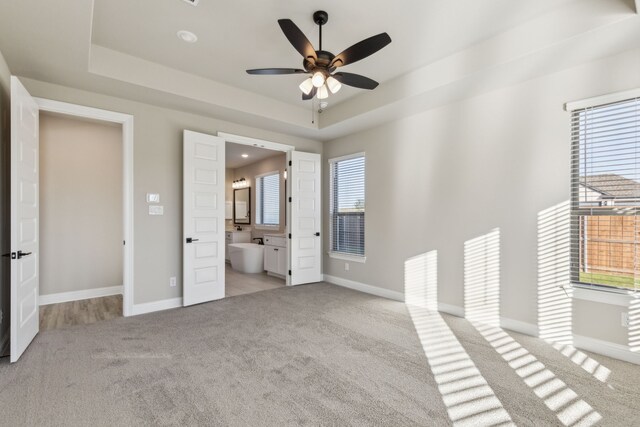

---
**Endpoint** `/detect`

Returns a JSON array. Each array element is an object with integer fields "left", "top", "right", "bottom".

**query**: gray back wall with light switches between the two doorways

[{"left": 23, "top": 79, "right": 322, "bottom": 304}]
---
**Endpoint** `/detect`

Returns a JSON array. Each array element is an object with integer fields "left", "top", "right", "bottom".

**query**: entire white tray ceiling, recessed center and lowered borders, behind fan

[{"left": 0, "top": 0, "right": 640, "bottom": 140}]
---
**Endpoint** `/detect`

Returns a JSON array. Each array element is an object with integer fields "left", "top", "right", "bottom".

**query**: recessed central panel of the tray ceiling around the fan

[{"left": 93, "top": 0, "right": 570, "bottom": 105}]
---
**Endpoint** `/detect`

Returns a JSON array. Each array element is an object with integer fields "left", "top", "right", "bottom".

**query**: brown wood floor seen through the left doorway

[{"left": 40, "top": 295, "right": 122, "bottom": 331}]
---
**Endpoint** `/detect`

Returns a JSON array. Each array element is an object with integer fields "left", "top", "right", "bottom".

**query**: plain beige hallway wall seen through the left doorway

[{"left": 40, "top": 113, "right": 123, "bottom": 295}]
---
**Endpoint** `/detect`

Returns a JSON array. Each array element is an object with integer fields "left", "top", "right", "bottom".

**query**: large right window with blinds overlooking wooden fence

[{"left": 571, "top": 98, "right": 640, "bottom": 290}]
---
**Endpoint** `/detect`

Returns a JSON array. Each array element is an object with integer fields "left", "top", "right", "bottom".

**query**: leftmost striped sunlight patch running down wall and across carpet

[{"left": 404, "top": 251, "right": 513, "bottom": 426}]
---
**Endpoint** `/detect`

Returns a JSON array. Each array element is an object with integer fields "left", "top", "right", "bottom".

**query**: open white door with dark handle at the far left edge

[{"left": 10, "top": 77, "right": 40, "bottom": 363}]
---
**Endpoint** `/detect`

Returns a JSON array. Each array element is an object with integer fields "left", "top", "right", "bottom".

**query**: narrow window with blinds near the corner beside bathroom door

[{"left": 329, "top": 153, "right": 365, "bottom": 257}]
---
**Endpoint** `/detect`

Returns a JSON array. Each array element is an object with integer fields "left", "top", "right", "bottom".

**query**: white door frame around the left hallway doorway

[{"left": 34, "top": 97, "right": 134, "bottom": 317}]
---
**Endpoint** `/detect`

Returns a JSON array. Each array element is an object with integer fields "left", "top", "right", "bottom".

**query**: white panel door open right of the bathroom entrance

[{"left": 288, "top": 151, "right": 322, "bottom": 285}]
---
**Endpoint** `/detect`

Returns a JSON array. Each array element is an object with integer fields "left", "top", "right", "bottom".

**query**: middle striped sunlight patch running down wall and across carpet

[{"left": 464, "top": 229, "right": 602, "bottom": 426}]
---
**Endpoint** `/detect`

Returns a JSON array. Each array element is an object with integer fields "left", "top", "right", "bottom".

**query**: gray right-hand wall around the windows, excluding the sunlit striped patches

[{"left": 323, "top": 47, "right": 640, "bottom": 344}]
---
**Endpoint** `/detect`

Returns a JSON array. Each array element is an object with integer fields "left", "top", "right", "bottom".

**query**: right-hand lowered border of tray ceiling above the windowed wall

[{"left": 320, "top": 0, "right": 640, "bottom": 140}]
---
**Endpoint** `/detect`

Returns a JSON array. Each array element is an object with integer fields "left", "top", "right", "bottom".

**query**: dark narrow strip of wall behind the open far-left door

[{"left": 0, "top": 47, "right": 11, "bottom": 355}]
